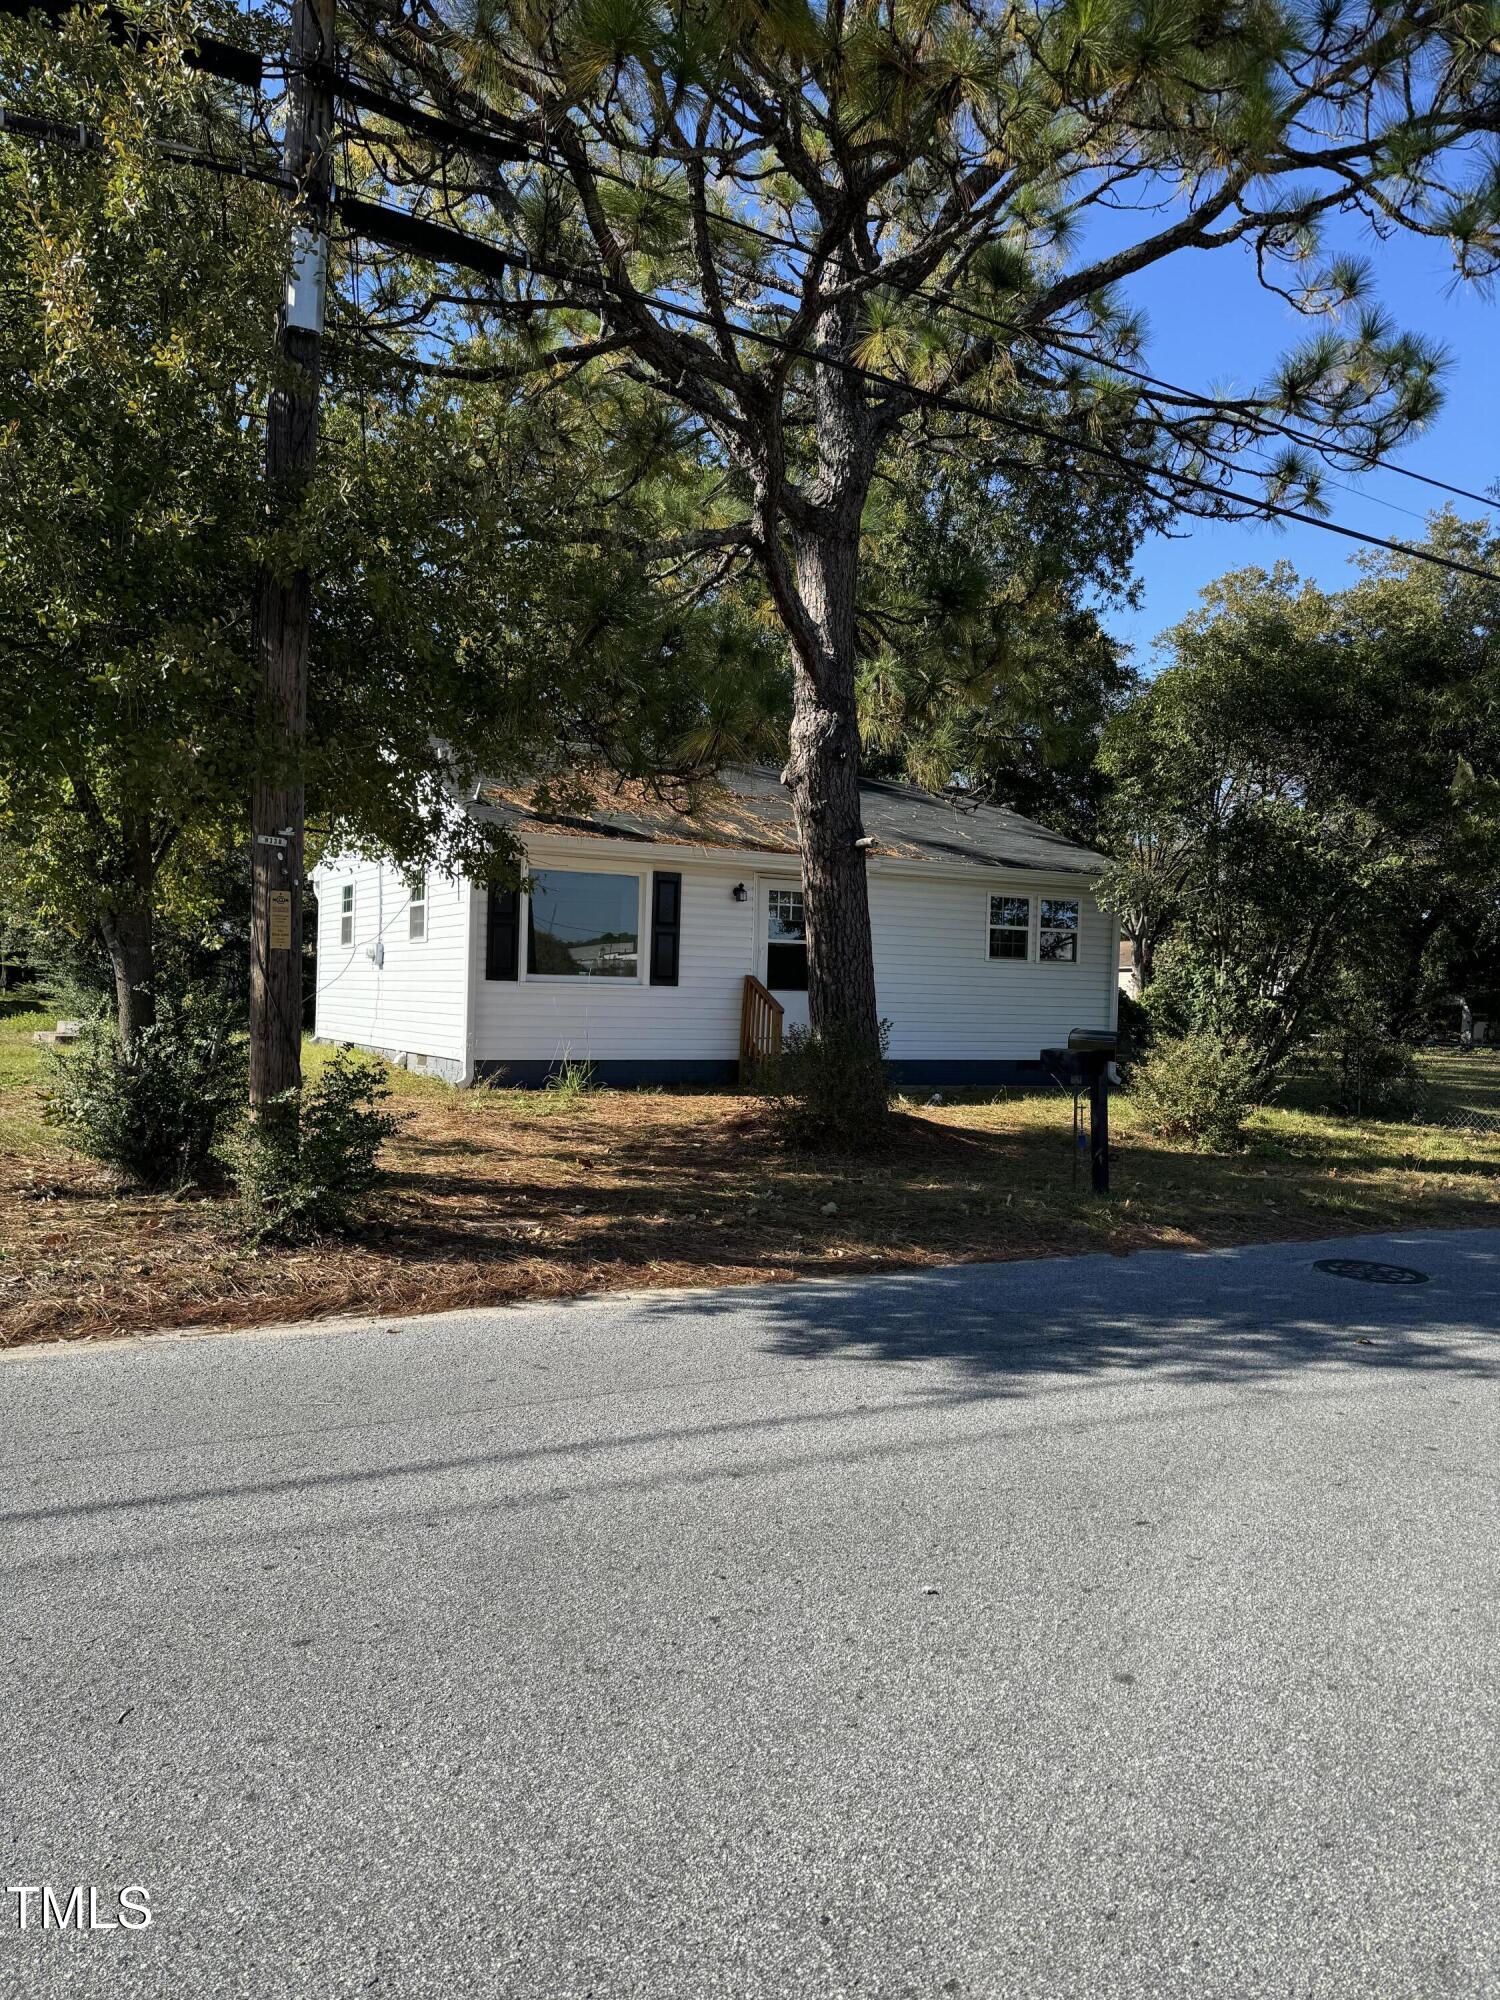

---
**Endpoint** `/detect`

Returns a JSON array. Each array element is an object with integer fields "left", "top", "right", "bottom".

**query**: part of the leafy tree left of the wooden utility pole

[{"left": 0, "top": 20, "right": 284, "bottom": 1034}]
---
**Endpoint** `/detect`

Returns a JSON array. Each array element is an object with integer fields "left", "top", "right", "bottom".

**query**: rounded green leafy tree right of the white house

[{"left": 1102, "top": 514, "right": 1500, "bottom": 1068}]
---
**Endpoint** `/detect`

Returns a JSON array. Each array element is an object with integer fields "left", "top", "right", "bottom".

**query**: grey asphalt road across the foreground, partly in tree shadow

[{"left": 0, "top": 1232, "right": 1500, "bottom": 2000}]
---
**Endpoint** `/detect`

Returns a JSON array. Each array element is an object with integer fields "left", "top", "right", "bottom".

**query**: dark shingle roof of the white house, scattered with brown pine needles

[{"left": 478, "top": 764, "right": 1104, "bottom": 874}]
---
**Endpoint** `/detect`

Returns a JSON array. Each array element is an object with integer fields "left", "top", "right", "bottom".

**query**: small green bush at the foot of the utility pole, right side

[{"left": 234, "top": 1048, "right": 396, "bottom": 1244}]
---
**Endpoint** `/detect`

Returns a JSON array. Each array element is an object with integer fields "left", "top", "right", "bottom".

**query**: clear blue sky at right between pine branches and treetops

[{"left": 1104, "top": 224, "right": 1500, "bottom": 670}]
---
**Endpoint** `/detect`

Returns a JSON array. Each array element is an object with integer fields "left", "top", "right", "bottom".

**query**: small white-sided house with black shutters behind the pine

[{"left": 314, "top": 768, "right": 1118, "bottom": 1084}]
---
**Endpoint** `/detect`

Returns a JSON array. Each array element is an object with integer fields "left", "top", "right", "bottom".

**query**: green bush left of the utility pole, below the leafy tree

[{"left": 46, "top": 998, "right": 246, "bottom": 1188}]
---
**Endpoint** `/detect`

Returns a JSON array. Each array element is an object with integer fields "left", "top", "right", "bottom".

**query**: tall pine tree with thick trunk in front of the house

[{"left": 332, "top": 0, "right": 1500, "bottom": 1110}]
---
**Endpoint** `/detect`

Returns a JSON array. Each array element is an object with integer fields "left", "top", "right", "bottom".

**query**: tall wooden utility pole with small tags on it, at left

[{"left": 250, "top": 0, "right": 334, "bottom": 1122}]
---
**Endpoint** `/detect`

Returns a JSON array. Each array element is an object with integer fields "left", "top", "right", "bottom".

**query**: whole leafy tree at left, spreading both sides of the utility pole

[{"left": 0, "top": 12, "right": 772, "bottom": 1040}]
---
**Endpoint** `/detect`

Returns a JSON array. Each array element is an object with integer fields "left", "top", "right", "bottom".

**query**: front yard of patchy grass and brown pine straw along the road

[{"left": 0, "top": 1012, "right": 1500, "bottom": 1346}]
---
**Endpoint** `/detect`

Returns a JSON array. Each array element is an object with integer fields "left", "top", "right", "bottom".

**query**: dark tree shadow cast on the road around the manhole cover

[{"left": 652, "top": 1230, "right": 1500, "bottom": 1396}]
